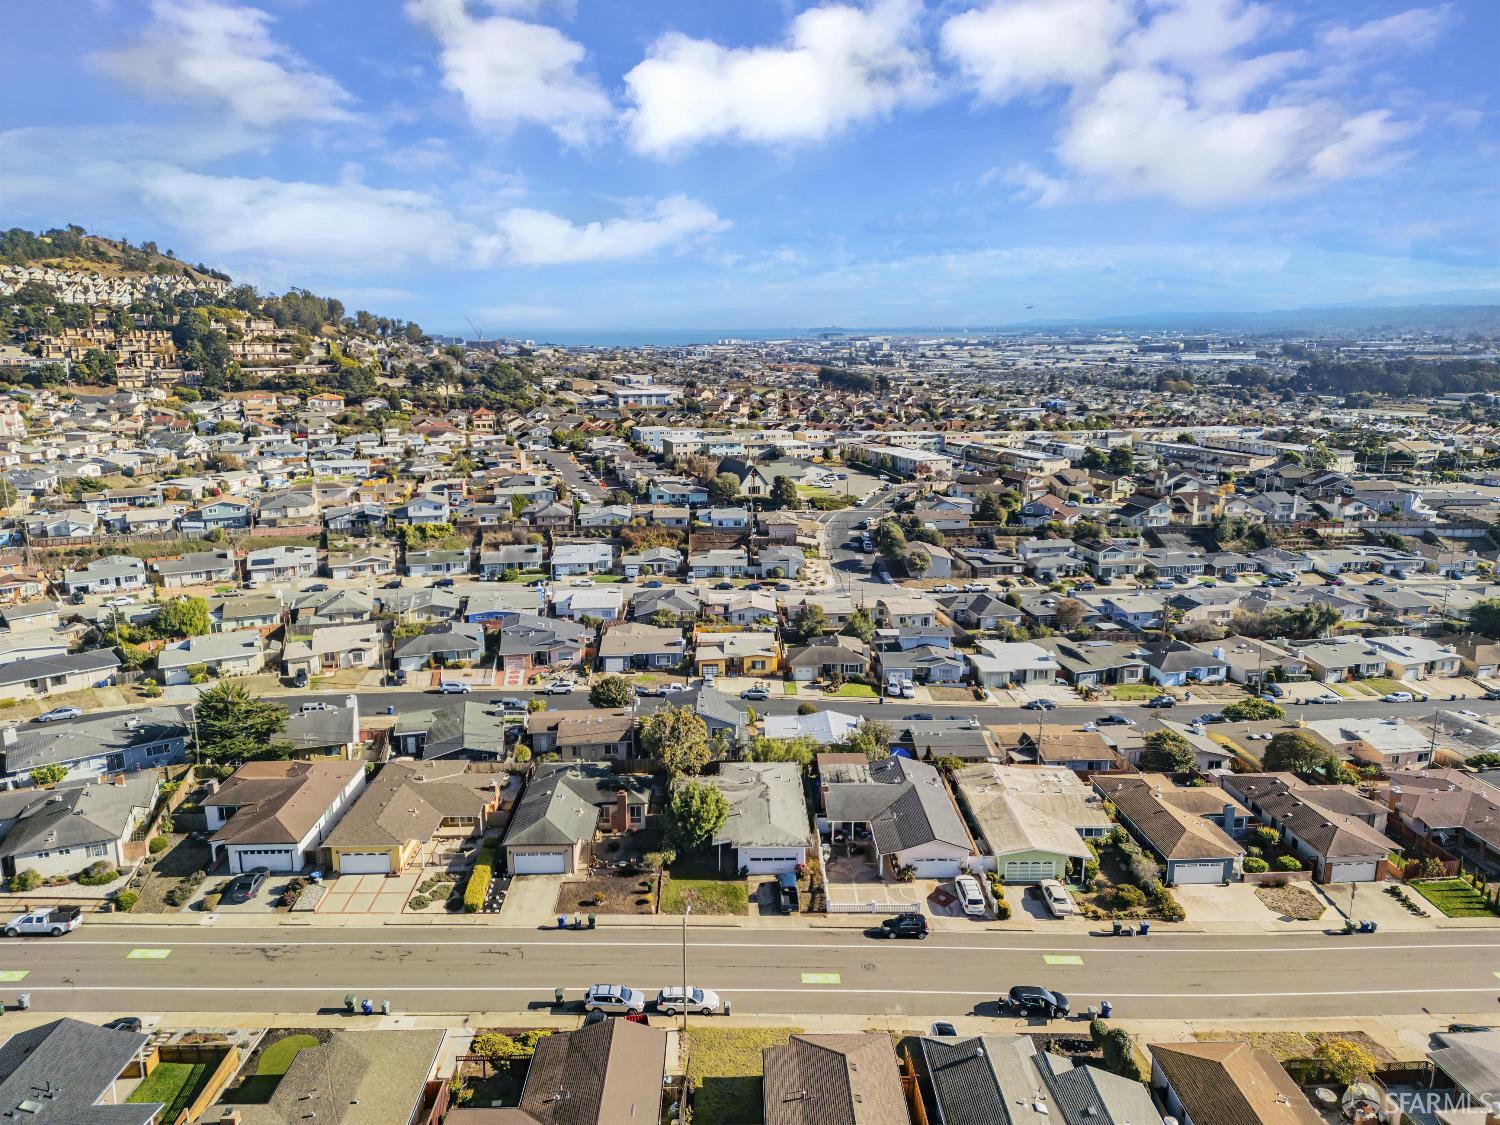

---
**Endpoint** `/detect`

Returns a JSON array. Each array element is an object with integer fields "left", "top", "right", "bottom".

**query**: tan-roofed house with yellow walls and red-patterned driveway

[{"left": 323, "top": 761, "right": 507, "bottom": 875}]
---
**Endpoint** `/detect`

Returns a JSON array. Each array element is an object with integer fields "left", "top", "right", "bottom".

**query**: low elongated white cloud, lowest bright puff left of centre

[{"left": 498, "top": 195, "right": 729, "bottom": 266}]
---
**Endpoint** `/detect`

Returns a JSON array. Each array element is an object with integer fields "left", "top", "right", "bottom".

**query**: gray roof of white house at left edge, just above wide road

[{"left": 0, "top": 771, "right": 156, "bottom": 869}]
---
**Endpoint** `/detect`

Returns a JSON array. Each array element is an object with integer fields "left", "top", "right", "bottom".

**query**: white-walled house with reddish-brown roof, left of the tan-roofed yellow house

[{"left": 203, "top": 759, "right": 366, "bottom": 875}]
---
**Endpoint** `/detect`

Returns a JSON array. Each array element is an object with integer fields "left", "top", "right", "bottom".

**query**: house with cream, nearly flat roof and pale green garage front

[{"left": 953, "top": 762, "right": 1115, "bottom": 884}]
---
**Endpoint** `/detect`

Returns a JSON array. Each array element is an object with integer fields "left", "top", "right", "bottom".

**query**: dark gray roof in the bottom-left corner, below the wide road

[{"left": 0, "top": 1019, "right": 165, "bottom": 1125}]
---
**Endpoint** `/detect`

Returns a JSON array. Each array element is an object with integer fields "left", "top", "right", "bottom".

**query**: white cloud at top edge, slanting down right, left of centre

[{"left": 407, "top": 0, "right": 614, "bottom": 144}]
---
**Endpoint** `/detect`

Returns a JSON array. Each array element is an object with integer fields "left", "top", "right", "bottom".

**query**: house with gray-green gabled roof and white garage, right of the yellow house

[{"left": 504, "top": 762, "right": 651, "bottom": 876}]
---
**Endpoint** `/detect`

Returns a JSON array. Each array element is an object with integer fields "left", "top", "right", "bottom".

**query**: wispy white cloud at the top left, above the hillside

[{"left": 95, "top": 0, "right": 351, "bottom": 128}]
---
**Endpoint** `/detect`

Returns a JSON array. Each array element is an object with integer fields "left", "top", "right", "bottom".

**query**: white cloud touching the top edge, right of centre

[{"left": 941, "top": 0, "right": 1136, "bottom": 102}]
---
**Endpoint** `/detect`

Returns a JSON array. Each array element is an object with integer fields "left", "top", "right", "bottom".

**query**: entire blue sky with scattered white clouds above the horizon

[{"left": 0, "top": 0, "right": 1500, "bottom": 338}]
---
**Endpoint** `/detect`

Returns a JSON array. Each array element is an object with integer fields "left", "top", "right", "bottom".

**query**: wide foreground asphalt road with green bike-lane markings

[{"left": 0, "top": 926, "right": 1500, "bottom": 1020}]
